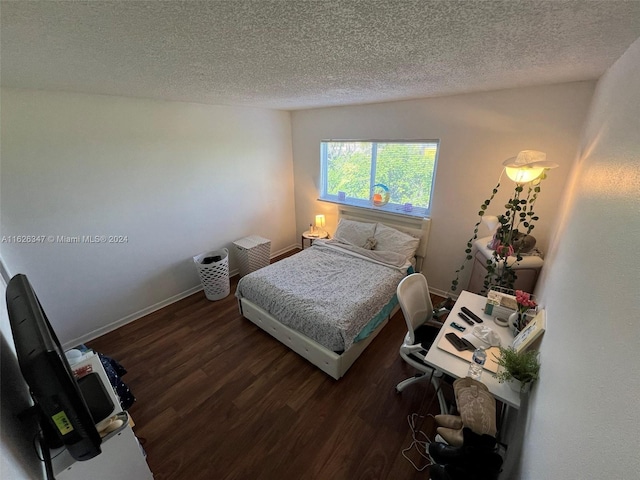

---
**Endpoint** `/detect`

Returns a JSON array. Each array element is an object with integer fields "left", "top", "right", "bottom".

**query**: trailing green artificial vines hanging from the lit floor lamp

[{"left": 450, "top": 171, "right": 547, "bottom": 292}]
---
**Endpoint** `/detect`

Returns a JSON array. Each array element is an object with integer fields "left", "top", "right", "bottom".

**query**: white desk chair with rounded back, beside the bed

[{"left": 396, "top": 273, "right": 448, "bottom": 413}]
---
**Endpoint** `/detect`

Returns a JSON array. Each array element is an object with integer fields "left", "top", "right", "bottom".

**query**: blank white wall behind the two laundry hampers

[{"left": 0, "top": 89, "right": 297, "bottom": 345}]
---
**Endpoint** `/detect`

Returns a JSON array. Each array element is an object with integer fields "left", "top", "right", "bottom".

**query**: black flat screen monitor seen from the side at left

[{"left": 6, "top": 274, "right": 101, "bottom": 461}]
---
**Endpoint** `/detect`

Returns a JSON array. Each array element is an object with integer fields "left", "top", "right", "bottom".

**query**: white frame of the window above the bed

[{"left": 318, "top": 139, "right": 440, "bottom": 218}]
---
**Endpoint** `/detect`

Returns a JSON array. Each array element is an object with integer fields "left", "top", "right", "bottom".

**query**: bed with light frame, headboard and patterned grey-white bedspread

[{"left": 236, "top": 208, "right": 430, "bottom": 380}]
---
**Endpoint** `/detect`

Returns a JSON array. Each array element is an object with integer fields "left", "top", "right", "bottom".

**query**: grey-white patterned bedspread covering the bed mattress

[{"left": 236, "top": 241, "right": 409, "bottom": 351}]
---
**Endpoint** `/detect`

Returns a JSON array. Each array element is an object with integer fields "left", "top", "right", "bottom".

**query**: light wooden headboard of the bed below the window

[{"left": 338, "top": 205, "right": 431, "bottom": 272}]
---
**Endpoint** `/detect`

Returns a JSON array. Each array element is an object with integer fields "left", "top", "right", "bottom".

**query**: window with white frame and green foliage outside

[{"left": 320, "top": 140, "right": 438, "bottom": 216}]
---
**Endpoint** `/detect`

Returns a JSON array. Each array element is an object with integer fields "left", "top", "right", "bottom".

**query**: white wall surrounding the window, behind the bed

[{"left": 292, "top": 82, "right": 594, "bottom": 293}]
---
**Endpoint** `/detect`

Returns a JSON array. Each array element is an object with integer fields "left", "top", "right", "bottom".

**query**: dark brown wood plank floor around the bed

[{"left": 89, "top": 251, "right": 444, "bottom": 480}]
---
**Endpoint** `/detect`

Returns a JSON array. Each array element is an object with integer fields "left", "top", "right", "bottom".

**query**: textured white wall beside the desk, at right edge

[{"left": 521, "top": 39, "right": 640, "bottom": 480}]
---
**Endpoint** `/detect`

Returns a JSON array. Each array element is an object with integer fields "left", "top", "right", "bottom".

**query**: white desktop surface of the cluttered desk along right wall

[{"left": 425, "top": 291, "right": 520, "bottom": 408}]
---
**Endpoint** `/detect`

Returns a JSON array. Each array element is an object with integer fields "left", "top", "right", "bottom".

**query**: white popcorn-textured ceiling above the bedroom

[{"left": 0, "top": 0, "right": 640, "bottom": 109}]
